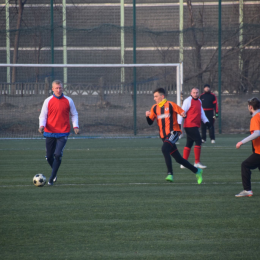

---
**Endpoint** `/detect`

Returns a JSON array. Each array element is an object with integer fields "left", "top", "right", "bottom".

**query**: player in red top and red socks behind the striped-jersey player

[{"left": 178, "top": 88, "right": 210, "bottom": 169}]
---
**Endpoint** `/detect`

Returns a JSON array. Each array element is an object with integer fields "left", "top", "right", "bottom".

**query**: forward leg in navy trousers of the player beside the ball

[{"left": 49, "top": 136, "right": 68, "bottom": 185}]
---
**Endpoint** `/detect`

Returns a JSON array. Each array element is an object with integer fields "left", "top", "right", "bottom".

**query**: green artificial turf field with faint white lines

[{"left": 0, "top": 135, "right": 260, "bottom": 260}]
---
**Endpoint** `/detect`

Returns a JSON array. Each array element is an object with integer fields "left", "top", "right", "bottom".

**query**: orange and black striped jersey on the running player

[{"left": 147, "top": 101, "right": 184, "bottom": 138}]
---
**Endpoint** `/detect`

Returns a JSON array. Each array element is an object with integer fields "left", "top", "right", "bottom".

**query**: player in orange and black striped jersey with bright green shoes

[{"left": 146, "top": 88, "right": 202, "bottom": 184}]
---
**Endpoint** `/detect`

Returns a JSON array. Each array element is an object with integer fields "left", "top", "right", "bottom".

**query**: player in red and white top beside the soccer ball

[{"left": 38, "top": 80, "right": 79, "bottom": 185}]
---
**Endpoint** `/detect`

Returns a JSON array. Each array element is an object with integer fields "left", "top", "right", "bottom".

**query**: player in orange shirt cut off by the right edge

[{"left": 235, "top": 98, "right": 260, "bottom": 197}]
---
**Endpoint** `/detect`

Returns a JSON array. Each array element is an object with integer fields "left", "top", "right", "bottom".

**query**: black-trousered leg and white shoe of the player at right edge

[{"left": 236, "top": 153, "right": 260, "bottom": 197}]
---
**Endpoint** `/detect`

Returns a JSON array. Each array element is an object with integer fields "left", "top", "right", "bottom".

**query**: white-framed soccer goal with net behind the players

[{"left": 0, "top": 63, "right": 182, "bottom": 138}]
